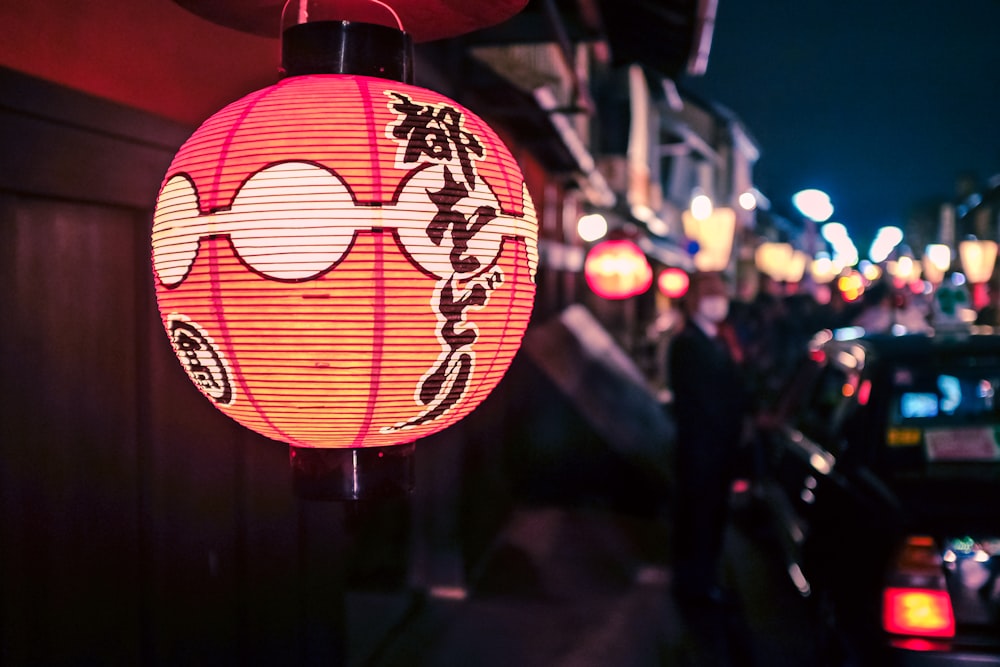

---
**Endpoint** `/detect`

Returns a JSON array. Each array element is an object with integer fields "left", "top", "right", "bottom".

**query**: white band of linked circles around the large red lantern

[{"left": 153, "top": 162, "right": 538, "bottom": 287}]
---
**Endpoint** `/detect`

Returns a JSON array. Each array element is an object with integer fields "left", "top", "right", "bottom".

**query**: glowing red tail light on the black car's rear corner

[{"left": 882, "top": 536, "right": 955, "bottom": 637}]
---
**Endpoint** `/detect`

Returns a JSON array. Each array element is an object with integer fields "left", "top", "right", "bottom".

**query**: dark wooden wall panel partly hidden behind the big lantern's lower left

[{"left": 141, "top": 312, "right": 242, "bottom": 664}]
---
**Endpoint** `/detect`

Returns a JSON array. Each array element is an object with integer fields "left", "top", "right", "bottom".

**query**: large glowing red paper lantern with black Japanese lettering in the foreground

[{"left": 152, "top": 0, "right": 538, "bottom": 497}]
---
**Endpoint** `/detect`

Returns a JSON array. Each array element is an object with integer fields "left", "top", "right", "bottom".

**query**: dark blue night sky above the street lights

[{"left": 680, "top": 0, "right": 1000, "bottom": 256}]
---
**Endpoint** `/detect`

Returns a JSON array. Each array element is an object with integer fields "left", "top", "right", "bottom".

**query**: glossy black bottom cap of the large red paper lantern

[{"left": 288, "top": 442, "right": 415, "bottom": 501}]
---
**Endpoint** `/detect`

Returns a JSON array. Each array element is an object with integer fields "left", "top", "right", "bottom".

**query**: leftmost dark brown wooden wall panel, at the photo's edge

[{"left": 0, "top": 196, "right": 141, "bottom": 664}]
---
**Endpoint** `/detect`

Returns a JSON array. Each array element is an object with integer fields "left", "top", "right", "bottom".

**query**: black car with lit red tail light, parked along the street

[{"left": 756, "top": 322, "right": 1000, "bottom": 665}]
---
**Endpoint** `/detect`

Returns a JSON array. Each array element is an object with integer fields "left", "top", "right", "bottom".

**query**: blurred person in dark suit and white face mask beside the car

[{"left": 667, "top": 272, "right": 748, "bottom": 602}]
